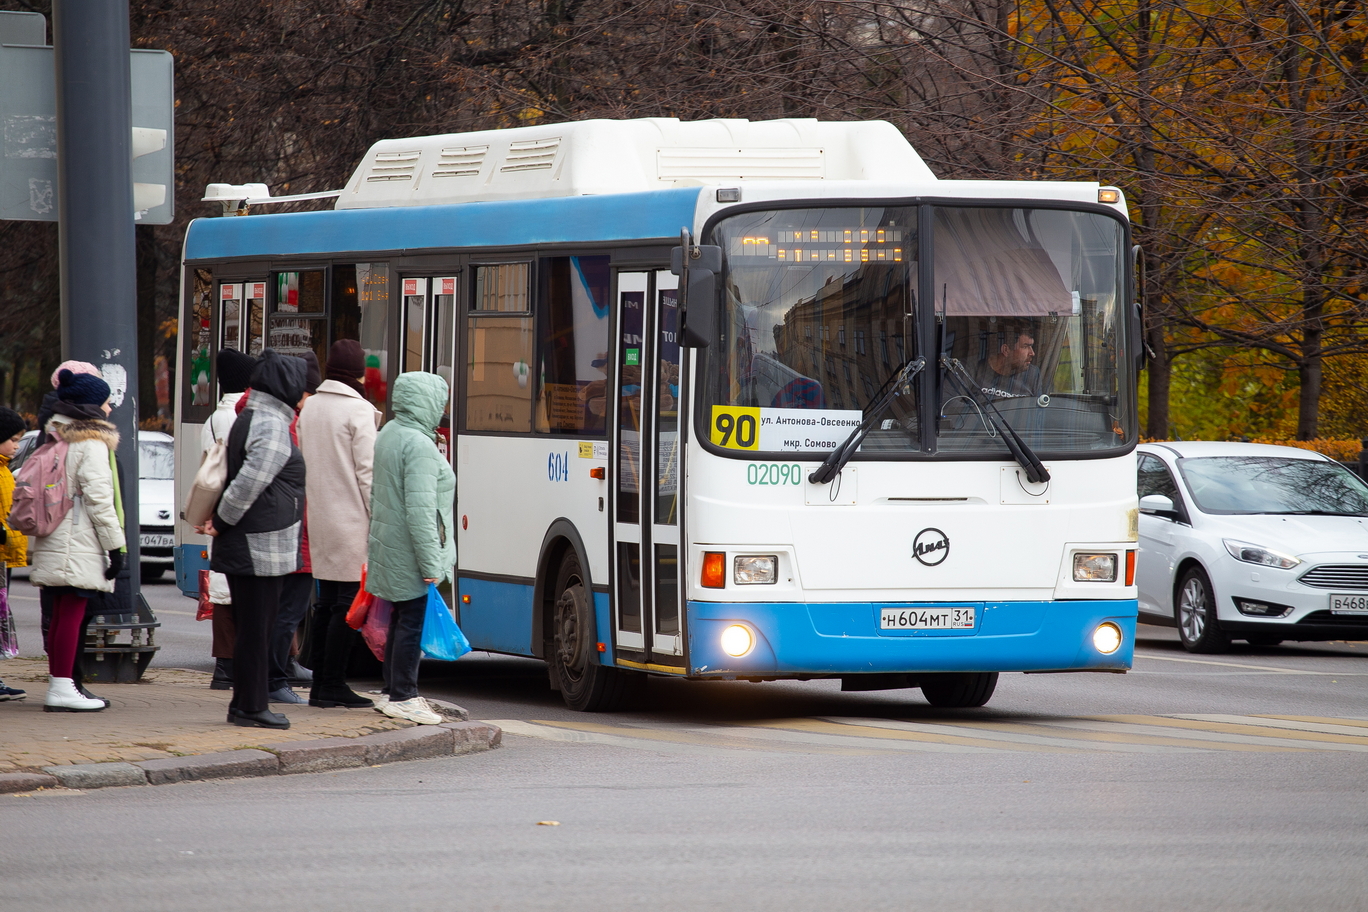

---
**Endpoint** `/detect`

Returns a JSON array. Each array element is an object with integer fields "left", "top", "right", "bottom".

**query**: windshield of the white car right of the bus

[{"left": 1178, "top": 457, "right": 1368, "bottom": 515}]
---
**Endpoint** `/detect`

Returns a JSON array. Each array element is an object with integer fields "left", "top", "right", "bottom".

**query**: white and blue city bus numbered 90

[{"left": 176, "top": 118, "right": 1141, "bottom": 711}]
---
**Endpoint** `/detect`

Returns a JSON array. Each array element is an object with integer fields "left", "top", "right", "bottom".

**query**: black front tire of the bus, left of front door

[{"left": 549, "top": 550, "right": 642, "bottom": 712}]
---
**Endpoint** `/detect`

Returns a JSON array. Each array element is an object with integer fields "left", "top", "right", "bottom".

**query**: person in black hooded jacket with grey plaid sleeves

[{"left": 202, "top": 349, "right": 306, "bottom": 729}]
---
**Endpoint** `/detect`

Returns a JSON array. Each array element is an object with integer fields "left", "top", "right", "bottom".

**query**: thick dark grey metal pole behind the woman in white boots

[{"left": 52, "top": 0, "right": 140, "bottom": 611}]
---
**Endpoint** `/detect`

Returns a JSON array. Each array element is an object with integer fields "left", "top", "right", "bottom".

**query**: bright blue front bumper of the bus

[{"left": 688, "top": 599, "right": 1137, "bottom": 677}]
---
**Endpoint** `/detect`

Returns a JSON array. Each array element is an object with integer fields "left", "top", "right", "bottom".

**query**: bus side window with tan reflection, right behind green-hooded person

[{"left": 465, "top": 263, "right": 532, "bottom": 433}]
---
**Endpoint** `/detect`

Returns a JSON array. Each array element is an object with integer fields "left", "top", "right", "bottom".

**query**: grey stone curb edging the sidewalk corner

[{"left": 17, "top": 721, "right": 503, "bottom": 793}]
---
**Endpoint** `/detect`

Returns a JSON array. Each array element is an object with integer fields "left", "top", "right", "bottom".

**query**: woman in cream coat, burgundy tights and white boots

[{"left": 29, "top": 371, "right": 124, "bottom": 712}]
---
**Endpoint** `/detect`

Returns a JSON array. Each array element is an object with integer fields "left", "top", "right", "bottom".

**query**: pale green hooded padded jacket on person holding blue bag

[{"left": 365, "top": 371, "right": 456, "bottom": 602}]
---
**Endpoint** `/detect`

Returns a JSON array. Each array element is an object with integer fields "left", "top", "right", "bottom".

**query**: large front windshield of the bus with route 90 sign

[{"left": 703, "top": 206, "right": 1135, "bottom": 457}]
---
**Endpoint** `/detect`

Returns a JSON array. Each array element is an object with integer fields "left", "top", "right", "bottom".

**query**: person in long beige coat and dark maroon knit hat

[{"left": 298, "top": 339, "right": 380, "bottom": 708}]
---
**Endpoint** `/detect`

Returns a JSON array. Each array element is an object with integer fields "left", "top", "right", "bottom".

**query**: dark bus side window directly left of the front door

[{"left": 536, "top": 257, "right": 610, "bottom": 435}]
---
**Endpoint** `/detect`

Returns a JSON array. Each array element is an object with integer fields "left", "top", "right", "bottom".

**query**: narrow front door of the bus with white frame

[{"left": 611, "top": 269, "right": 684, "bottom": 671}]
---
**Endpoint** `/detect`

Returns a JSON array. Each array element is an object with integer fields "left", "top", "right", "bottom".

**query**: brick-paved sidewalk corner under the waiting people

[{"left": 0, "top": 659, "right": 499, "bottom": 792}]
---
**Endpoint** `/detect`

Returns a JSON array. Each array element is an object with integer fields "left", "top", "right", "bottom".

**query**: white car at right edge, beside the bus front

[{"left": 1135, "top": 442, "right": 1368, "bottom": 652}]
